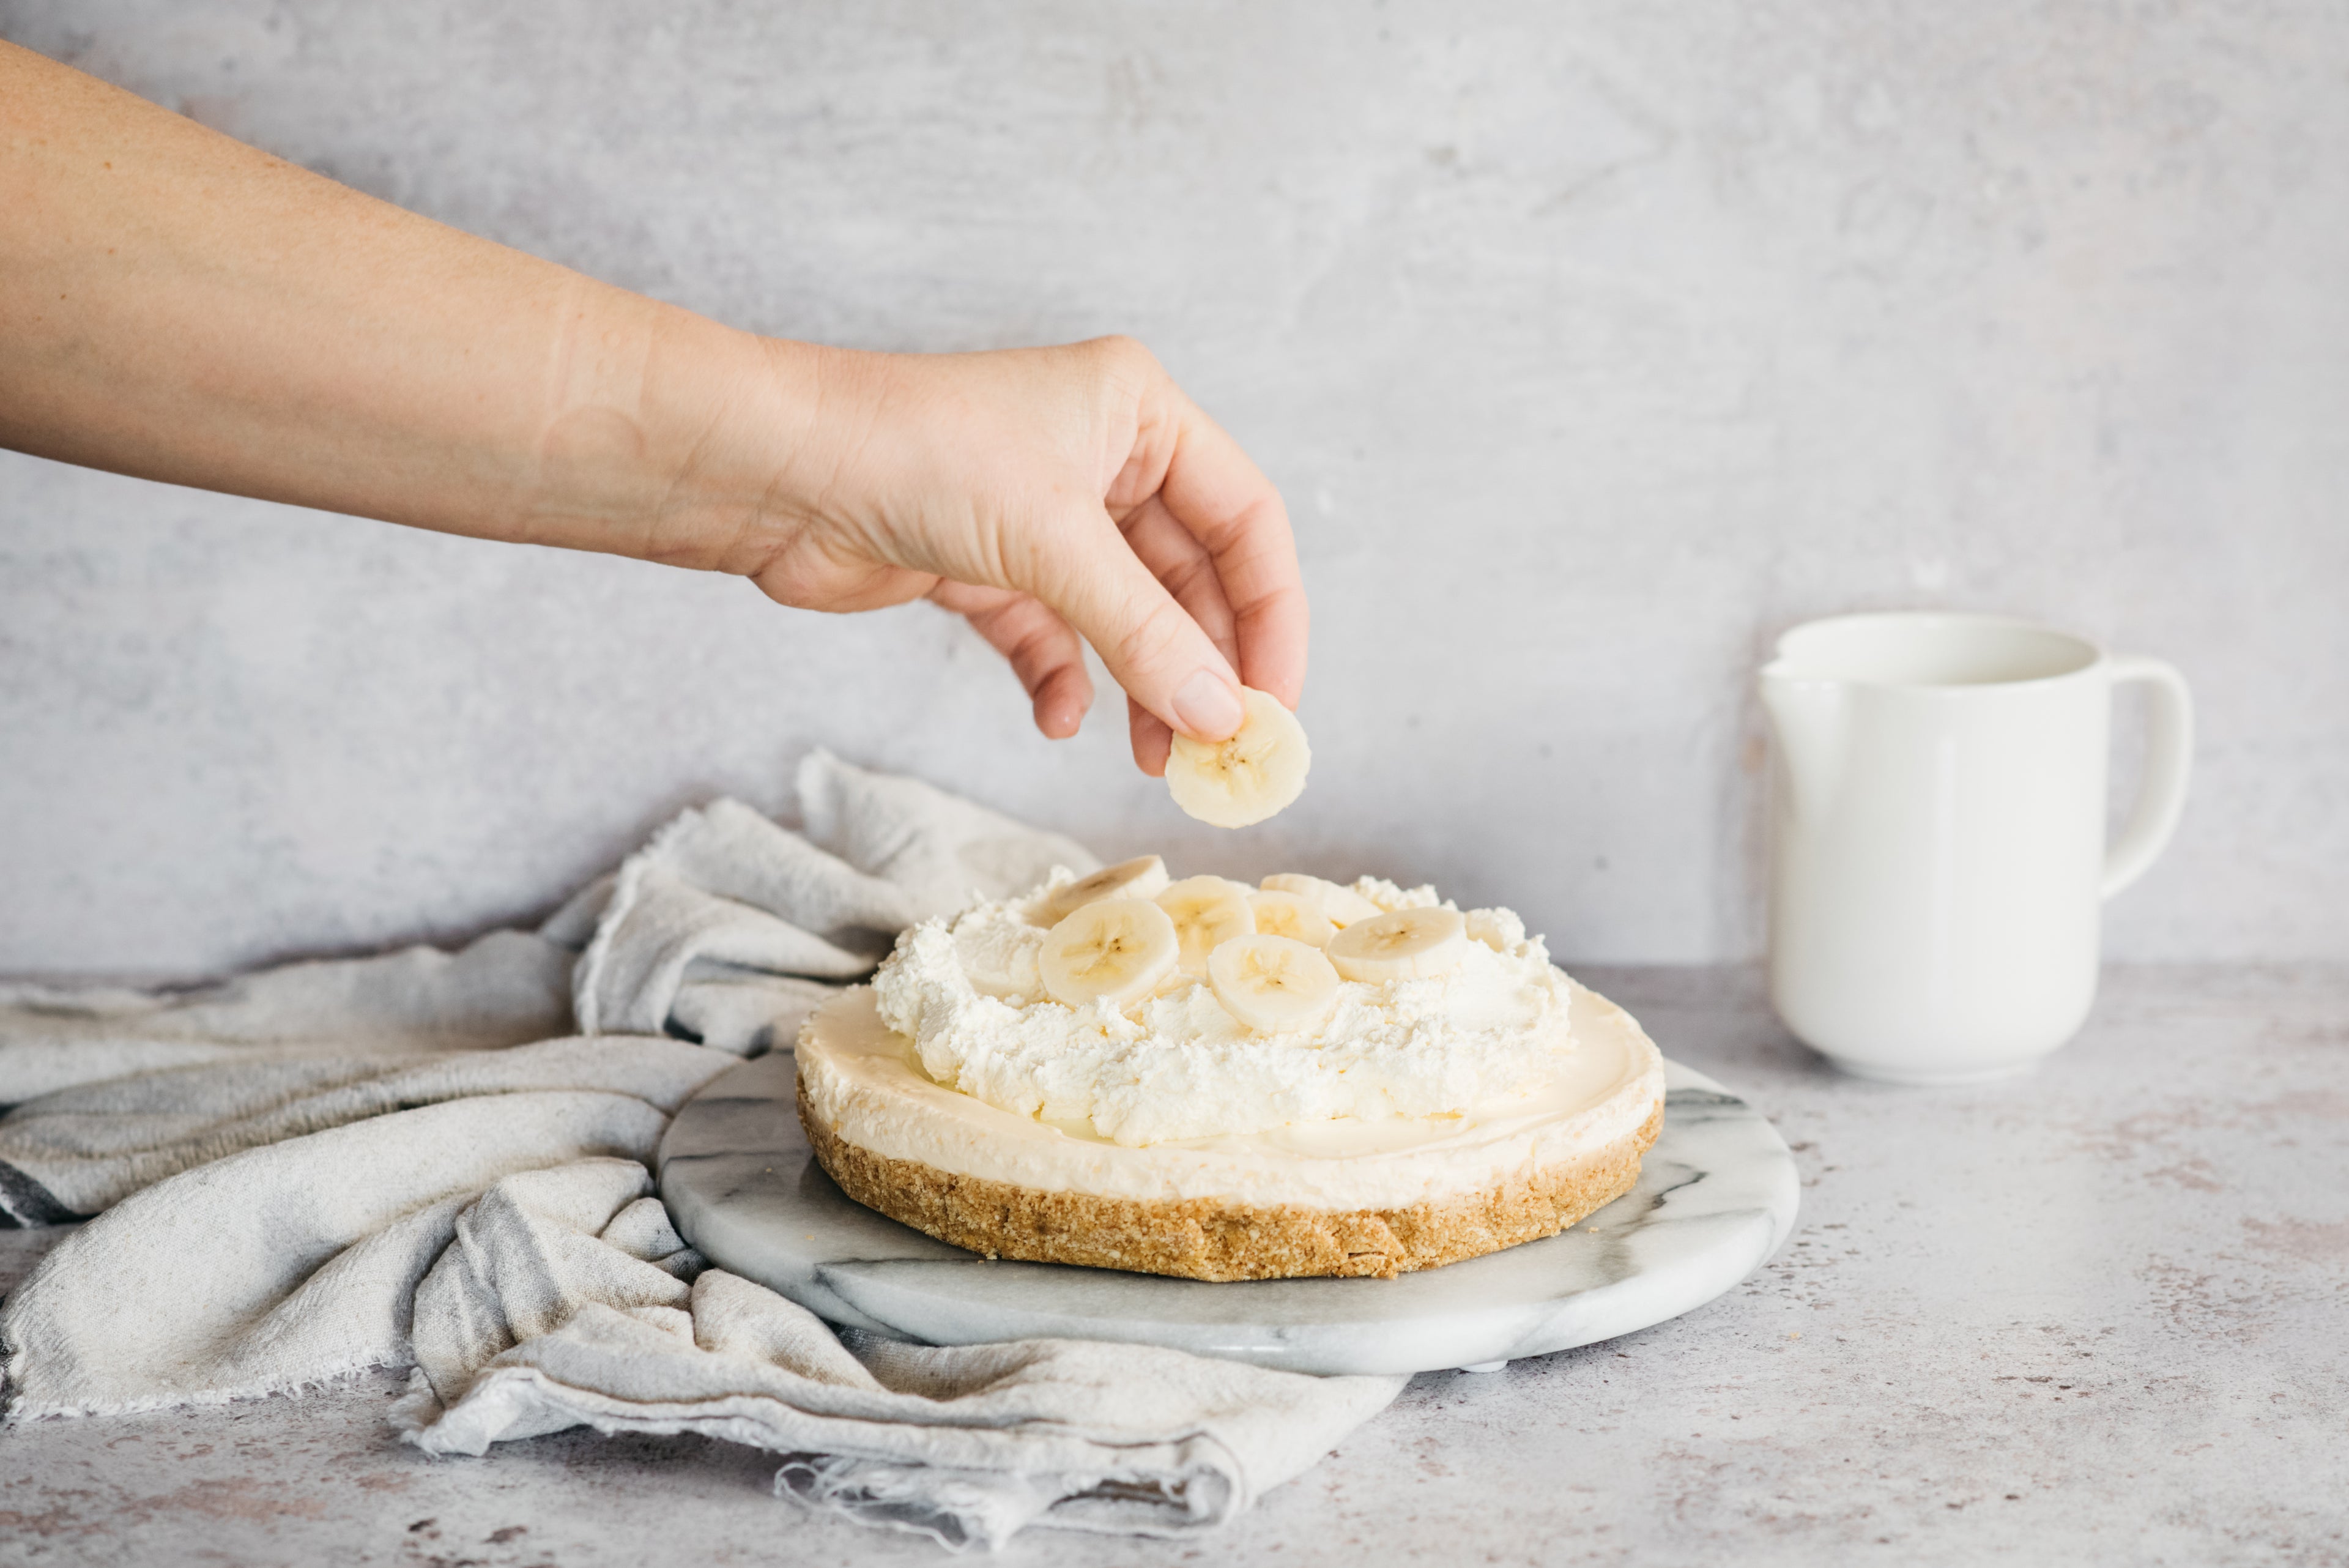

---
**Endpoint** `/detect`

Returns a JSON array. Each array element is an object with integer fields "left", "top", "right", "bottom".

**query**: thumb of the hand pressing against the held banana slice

[{"left": 1017, "top": 510, "right": 1247, "bottom": 740}]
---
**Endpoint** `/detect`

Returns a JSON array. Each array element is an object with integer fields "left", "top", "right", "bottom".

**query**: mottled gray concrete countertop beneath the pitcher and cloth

[{"left": 0, "top": 966, "right": 2349, "bottom": 1568}]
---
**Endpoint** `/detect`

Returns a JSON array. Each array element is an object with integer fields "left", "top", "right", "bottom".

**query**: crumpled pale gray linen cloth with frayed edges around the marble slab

[{"left": 0, "top": 752, "right": 1402, "bottom": 1547}]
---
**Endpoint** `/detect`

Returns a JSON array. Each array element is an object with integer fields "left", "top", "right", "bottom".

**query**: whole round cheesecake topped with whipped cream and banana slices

[{"left": 796, "top": 856, "right": 1663, "bottom": 1281}]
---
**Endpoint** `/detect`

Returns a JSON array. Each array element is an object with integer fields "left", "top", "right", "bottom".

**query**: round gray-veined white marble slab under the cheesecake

[{"left": 660, "top": 1051, "right": 1797, "bottom": 1373}]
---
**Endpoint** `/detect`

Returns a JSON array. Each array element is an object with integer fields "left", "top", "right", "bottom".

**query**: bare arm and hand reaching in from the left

[{"left": 0, "top": 45, "right": 1306, "bottom": 771}]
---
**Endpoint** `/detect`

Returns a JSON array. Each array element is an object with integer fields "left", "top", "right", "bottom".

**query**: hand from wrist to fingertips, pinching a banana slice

[{"left": 733, "top": 338, "right": 1306, "bottom": 776}]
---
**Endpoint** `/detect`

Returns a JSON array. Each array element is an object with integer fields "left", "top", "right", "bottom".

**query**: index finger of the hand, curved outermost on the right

[{"left": 1158, "top": 385, "right": 1311, "bottom": 708}]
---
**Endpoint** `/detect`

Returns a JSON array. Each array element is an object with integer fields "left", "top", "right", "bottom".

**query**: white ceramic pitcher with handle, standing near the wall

[{"left": 1762, "top": 614, "right": 2194, "bottom": 1083}]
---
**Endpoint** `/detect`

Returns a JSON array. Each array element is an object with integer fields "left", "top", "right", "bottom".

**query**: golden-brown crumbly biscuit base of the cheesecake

[{"left": 799, "top": 1082, "right": 1663, "bottom": 1279}]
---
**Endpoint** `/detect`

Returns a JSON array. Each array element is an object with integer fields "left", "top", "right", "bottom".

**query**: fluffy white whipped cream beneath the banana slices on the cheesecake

[{"left": 874, "top": 870, "right": 1576, "bottom": 1147}]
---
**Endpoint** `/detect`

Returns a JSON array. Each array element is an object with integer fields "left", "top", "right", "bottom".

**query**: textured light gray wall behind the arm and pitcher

[{"left": 0, "top": 0, "right": 2349, "bottom": 973}]
